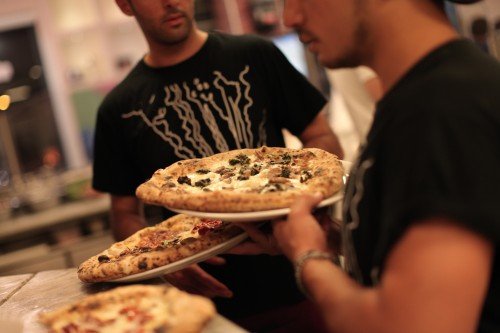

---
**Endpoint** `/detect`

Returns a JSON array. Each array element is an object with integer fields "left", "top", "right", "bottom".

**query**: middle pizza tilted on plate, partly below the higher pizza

[{"left": 78, "top": 214, "right": 243, "bottom": 282}]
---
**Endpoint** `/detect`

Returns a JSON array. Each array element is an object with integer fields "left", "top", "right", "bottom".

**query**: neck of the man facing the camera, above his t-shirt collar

[{"left": 144, "top": 28, "right": 208, "bottom": 67}]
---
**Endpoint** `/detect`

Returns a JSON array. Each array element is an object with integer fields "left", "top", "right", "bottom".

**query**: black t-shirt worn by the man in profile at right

[{"left": 344, "top": 40, "right": 500, "bottom": 332}]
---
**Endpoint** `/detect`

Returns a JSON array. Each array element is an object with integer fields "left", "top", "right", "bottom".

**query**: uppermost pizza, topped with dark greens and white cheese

[{"left": 136, "top": 147, "right": 344, "bottom": 213}]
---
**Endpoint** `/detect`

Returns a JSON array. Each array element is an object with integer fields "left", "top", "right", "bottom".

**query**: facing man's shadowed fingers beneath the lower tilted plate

[{"left": 165, "top": 265, "right": 233, "bottom": 298}]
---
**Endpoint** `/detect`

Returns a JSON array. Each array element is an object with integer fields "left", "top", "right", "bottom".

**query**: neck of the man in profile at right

[{"left": 367, "top": 0, "right": 458, "bottom": 93}]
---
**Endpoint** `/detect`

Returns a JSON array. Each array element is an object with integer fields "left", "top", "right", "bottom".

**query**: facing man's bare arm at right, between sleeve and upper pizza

[{"left": 299, "top": 111, "right": 344, "bottom": 159}]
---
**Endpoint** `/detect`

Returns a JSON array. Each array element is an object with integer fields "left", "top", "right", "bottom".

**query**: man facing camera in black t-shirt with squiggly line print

[{"left": 93, "top": 0, "right": 342, "bottom": 326}]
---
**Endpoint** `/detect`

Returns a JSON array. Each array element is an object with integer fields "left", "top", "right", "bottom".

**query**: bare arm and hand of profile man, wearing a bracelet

[{"left": 274, "top": 196, "right": 493, "bottom": 333}]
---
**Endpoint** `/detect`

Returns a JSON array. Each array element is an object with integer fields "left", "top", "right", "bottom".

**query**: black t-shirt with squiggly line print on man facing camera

[{"left": 93, "top": 33, "right": 326, "bottom": 318}]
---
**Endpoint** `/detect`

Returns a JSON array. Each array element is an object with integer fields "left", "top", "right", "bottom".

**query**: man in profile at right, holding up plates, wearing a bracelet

[{"left": 239, "top": 0, "right": 500, "bottom": 333}]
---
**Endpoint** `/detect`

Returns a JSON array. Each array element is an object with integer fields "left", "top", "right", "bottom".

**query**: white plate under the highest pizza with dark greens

[{"left": 167, "top": 190, "right": 344, "bottom": 222}]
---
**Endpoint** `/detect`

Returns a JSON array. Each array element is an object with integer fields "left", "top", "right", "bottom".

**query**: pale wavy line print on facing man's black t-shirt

[{"left": 122, "top": 66, "right": 267, "bottom": 159}]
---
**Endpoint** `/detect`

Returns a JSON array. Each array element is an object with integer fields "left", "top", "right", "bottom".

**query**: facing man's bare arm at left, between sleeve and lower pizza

[{"left": 110, "top": 195, "right": 147, "bottom": 241}]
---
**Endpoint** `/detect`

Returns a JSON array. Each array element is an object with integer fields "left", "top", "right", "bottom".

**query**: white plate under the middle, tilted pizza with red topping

[{"left": 111, "top": 233, "right": 248, "bottom": 282}]
